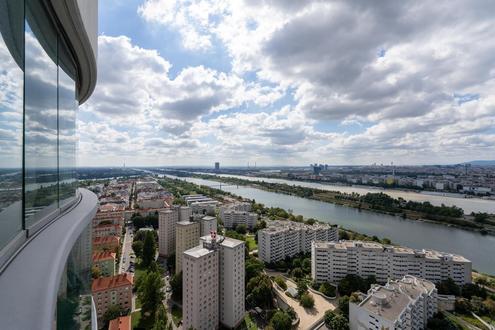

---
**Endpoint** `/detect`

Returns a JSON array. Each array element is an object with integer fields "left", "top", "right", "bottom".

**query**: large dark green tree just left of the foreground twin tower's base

[{"left": 137, "top": 271, "right": 165, "bottom": 319}]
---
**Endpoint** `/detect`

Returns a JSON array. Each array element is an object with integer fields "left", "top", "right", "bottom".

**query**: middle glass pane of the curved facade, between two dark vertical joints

[{"left": 24, "top": 16, "right": 58, "bottom": 227}]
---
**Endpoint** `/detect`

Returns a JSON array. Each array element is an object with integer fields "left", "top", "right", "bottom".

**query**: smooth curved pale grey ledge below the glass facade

[{"left": 0, "top": 189, "right": 98, "bottom": 329}]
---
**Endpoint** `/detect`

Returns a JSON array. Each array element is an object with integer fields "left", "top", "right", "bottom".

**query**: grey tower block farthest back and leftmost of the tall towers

[{"left": 158, "top": 206, "right": 191, "bottom": 257}]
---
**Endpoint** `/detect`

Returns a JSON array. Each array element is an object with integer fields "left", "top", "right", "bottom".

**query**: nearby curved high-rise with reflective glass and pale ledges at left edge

[{"left": 0, "top": 0, "right": 98, "bottom": 329}]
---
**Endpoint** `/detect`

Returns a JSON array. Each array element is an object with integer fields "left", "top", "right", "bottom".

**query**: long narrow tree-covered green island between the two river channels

[{"left": 166, "top": 172, "right": 495, "bottom": 235}]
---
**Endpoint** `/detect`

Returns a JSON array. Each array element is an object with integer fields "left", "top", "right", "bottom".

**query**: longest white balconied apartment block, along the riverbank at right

[{"left": 311, "top": 241, "right": 471, "bottom": 285}]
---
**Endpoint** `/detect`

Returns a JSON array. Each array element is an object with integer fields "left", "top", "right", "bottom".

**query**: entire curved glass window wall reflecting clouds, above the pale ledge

[{"left": 0, "top": 0, "right": 78, "bottom": 251}]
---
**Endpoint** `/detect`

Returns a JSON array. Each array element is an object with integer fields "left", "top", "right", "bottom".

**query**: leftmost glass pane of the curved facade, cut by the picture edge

[{"left": 0, "top": 0, "right": 24, "bottom": 249}]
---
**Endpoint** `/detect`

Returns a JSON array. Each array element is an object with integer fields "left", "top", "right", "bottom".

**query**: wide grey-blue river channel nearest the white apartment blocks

[{"left": 170, "top": 176, "right": 495, "bottom": 274}]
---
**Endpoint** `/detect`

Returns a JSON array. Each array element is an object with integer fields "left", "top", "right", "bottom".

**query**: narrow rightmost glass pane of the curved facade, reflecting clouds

[{"left": 58, "top": 48, "right": 77, "bottom": 207}]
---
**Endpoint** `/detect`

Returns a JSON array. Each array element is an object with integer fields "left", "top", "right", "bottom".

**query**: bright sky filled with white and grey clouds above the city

[{"left": 78, "top": 0, "right": 495, "bottom": 166}]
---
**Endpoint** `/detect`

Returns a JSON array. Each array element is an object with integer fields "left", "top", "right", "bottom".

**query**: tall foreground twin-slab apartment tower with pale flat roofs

[{"left": 182, "top": 233, "right": 245, "bottom": 329}]
